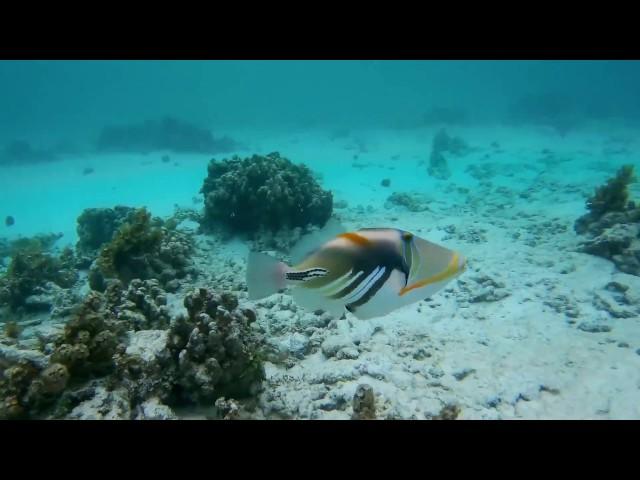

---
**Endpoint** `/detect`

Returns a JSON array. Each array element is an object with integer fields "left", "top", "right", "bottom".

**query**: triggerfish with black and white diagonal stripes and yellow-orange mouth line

[{"left": 247, "top": 223, "right": 466, "bottom": 319}]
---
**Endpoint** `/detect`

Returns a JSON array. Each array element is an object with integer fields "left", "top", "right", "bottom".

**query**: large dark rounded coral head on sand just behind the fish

[{"left": 201, "top": 153, "right": 333, "bottom": 234}]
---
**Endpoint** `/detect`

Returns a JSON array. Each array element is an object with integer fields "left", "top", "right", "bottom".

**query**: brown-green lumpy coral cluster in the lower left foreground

[{"left": 0, "top": 280, "right": 265, "bottom": 419}]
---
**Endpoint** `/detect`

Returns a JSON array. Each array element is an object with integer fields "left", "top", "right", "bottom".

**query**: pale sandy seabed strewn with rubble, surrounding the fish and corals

[{"left": 0, "top": 127, "right": 640, "bottom": 419}]
